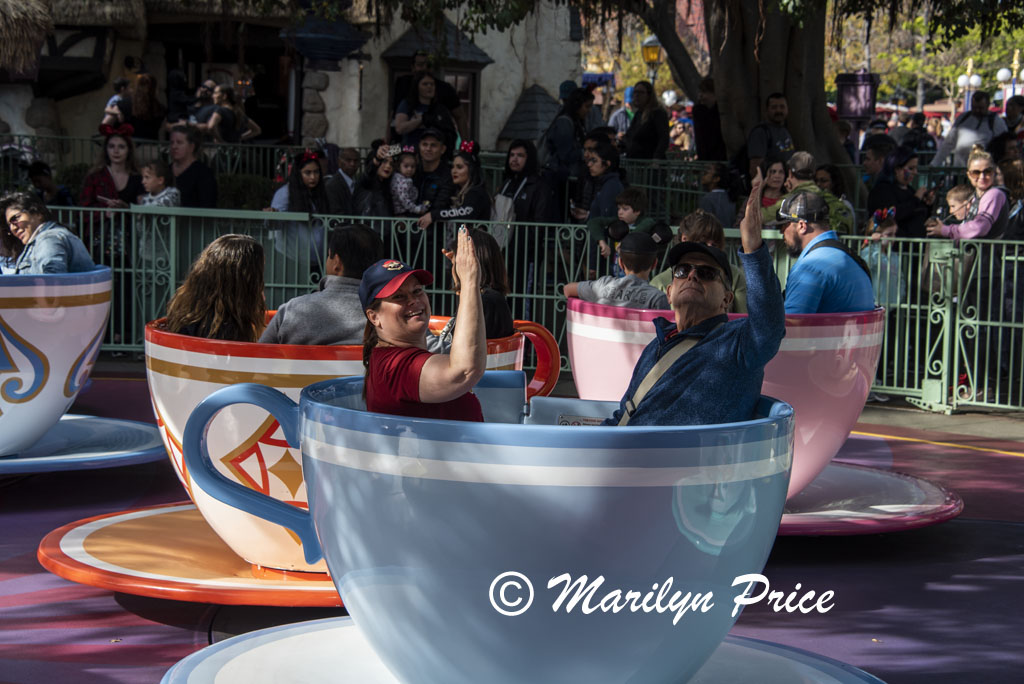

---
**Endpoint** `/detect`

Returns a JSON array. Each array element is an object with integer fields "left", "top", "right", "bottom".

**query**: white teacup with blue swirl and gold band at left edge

[{"left": 0, "top": 266, "right": 111, "bottom": 456}]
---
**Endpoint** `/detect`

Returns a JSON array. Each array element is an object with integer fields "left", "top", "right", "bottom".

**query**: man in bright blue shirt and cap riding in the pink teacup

[{"left": 778, "top": 191, "right": 874, "bottom": 313}]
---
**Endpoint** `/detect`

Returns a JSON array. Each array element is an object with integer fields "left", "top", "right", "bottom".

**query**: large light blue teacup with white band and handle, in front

[{"left": 184, "top": 372, "right": 794, "bottom": 684}]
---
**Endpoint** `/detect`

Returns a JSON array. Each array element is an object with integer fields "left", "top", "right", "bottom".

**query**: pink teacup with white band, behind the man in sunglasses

[{"left": 566, "top": 298, "right": 885, "bottom": 497}]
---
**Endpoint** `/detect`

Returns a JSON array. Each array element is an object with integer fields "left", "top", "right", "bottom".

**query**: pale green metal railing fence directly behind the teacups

[{"left": 39, "top": 207, "right": 1024, "bottom": 413}]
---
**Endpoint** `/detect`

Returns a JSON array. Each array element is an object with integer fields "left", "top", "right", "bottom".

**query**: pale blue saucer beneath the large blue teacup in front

[{"left": 161, "top": 617, "right": 884, "bottom": 684}]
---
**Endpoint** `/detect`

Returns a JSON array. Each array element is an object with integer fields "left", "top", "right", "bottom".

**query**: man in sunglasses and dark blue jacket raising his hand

[{"left": 605, "top": 171, "right": 785, "bottom": 425}]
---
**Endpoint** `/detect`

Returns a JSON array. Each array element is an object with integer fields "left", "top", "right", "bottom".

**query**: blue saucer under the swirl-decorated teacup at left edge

[{"left": 0, "top": 415, "right": 167, "bottom": 475}]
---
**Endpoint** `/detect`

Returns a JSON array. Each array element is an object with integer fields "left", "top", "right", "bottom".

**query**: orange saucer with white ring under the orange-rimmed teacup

[{"left": 37, "top": 503, "right": 341, "bottom": 607}]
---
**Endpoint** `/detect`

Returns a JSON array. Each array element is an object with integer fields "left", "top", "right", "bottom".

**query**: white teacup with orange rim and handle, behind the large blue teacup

[{"left": 145, "top": 312, "right": 559, "bottom": 576}]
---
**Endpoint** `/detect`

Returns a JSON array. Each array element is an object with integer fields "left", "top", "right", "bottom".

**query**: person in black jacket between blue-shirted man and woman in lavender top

[{"left": 867, "top": 145, "right": 935, "bottom": 238}]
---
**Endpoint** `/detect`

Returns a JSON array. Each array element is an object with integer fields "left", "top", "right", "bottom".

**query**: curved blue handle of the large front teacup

[{"left": 181, "top": 383, "right": 324, "bottom": 564}]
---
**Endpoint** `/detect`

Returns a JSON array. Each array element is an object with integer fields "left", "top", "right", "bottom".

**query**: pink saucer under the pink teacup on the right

[{"left": 778, "top": 463, "right": 964, "bottom": 536}]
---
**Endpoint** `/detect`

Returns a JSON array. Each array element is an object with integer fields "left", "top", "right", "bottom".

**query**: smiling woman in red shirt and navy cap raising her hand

[{"left": 359, "top": 226, "right": 487, "bottom": 422}]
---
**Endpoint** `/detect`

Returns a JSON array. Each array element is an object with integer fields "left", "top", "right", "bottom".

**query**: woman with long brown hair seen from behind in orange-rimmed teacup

[{"left": 164, "top": 233, "right": 266, "bottom": 342}]
